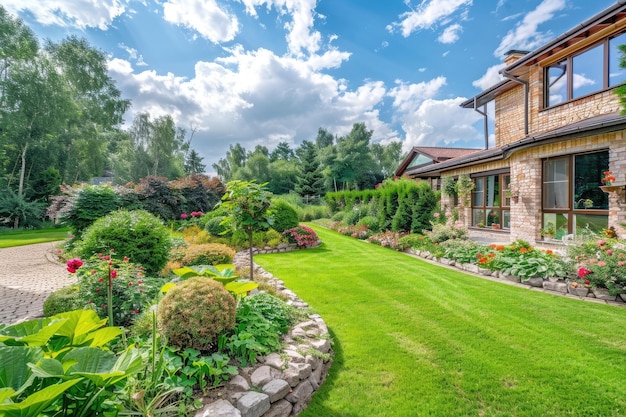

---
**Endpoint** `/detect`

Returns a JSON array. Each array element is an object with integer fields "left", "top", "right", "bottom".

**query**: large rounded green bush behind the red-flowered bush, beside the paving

[{"left": 75, "top": 210, "right": 172, "bottom": 275}]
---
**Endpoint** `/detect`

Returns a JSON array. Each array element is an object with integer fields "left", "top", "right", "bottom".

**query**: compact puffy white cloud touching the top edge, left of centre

[{"left": 163, "top": 0, "right": 239, "bottom": 43}]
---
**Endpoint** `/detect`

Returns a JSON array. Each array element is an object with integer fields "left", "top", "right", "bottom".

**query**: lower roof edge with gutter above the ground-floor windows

[{"left": 408, "top": 113, "right": 626, "bottom": 177}]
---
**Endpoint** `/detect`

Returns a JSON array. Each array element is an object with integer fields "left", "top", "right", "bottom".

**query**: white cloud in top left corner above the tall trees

[{"left": 2, "top": 0, "right": 128, "bottom": 30}]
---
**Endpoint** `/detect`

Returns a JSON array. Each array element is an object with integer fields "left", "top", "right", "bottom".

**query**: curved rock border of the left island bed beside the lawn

[{"left": 194, "top": 249, "right": 333, "bottom": 417}]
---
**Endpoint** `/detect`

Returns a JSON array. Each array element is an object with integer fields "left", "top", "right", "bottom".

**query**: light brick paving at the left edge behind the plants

[{"left": 0, "top": 242, "right": 75, "bottom": 324}]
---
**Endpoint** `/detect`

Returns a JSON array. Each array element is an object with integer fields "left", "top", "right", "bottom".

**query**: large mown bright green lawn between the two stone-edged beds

[{"left": 255, "top": 227, "right": 626, "bottom": 417}]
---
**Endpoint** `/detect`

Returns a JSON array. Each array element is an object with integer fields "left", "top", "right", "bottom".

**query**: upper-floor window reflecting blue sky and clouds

[{"left": 544, "top": 33, "right": 626, "bottom": 107}]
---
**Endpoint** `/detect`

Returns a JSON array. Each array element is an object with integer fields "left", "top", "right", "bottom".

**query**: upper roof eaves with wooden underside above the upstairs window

[{"left": 461, "top": 0, "right": 626, "bottom": 108}]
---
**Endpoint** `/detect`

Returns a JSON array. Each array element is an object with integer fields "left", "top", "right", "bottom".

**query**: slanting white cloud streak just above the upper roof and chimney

[{"left": 494, "top": 0, "right": 566, "bottom": 58}]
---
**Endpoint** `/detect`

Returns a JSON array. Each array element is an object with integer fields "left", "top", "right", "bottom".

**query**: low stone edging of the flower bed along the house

[{"left": 404, "top": 249, "right": 626, "bottom": 307}]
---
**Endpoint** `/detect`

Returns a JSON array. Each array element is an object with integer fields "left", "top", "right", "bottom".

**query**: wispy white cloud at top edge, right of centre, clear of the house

[{"left": 387, "top": 0, "right": 472, "bottom": 37}]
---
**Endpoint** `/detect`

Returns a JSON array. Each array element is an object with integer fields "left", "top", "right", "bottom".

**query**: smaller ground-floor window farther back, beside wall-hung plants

[{"left": 472, "top": 172, "right": 511, "bottom": 229}]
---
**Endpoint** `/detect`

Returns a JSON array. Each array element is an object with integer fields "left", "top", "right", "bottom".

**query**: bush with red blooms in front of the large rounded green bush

[{"left": 67, "top": 250, "right": 162, "bottom": 326}]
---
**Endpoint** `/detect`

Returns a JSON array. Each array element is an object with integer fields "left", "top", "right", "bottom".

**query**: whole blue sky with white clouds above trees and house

[{"left": 0, "top": 0, "right": 615, "bottom": 175}]
